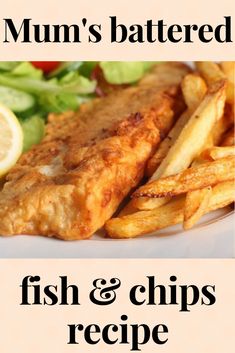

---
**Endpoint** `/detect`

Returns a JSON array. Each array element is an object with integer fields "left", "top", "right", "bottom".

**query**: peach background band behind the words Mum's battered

[{"left": 0, "top": 0, "right": 235, "bottom": 60}]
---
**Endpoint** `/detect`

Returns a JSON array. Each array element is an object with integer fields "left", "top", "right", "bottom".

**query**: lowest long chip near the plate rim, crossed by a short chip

[{"left": 105, "top": 181, "right": 235, "bottom": 239}]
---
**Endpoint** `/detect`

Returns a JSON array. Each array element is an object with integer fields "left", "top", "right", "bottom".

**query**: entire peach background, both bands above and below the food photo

[{"left": 0, "top": 0, "right": 235, "bottom": 353}]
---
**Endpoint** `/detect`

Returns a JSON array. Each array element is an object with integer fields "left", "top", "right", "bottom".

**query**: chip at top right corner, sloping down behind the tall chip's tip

[{"left": 196, "top": 61, "right": 234, "bottom": 104}]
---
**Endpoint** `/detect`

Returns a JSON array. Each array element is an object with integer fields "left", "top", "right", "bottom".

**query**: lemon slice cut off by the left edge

[{"left": 0, "top": 104, "right": 23, "bottom": 177}]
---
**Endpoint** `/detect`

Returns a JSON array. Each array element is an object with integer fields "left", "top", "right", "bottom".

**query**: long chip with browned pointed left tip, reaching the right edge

[{"left": 132, "top": 156, "right": 235, "bottom": 198}]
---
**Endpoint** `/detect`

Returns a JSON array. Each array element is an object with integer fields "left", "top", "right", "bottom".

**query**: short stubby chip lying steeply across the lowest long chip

[{"left": 183, "top": 186, "right": 212, "bottom": 229}]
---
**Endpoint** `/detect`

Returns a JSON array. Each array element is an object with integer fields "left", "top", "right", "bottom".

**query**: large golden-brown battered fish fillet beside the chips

[{"left": 0, "top": 63, "right": 189, "bottom": 240}]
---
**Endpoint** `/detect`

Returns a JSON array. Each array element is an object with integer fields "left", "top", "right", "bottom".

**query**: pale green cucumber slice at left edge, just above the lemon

[{"left": 0, "top": 86, "right": 36, "bottom": 114}]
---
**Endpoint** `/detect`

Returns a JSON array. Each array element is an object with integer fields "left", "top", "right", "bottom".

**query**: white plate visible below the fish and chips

[{"left": 0, "top": 209, "right": 235, "bottom": 258}]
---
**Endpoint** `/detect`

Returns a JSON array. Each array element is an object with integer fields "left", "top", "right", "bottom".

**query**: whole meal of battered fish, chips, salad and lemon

[{"left": 0, "top": 62, "right": 235, "bottom": 240}]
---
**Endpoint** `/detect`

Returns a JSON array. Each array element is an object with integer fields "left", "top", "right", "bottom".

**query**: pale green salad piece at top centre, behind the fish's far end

[{"left": 100, "top": 61, "right": 154, "bottom": 84}]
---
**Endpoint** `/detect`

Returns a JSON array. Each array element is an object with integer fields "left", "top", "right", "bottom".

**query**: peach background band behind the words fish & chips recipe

[{"left": 0, "top": 259, "right": 235, "bottom": 353}]
